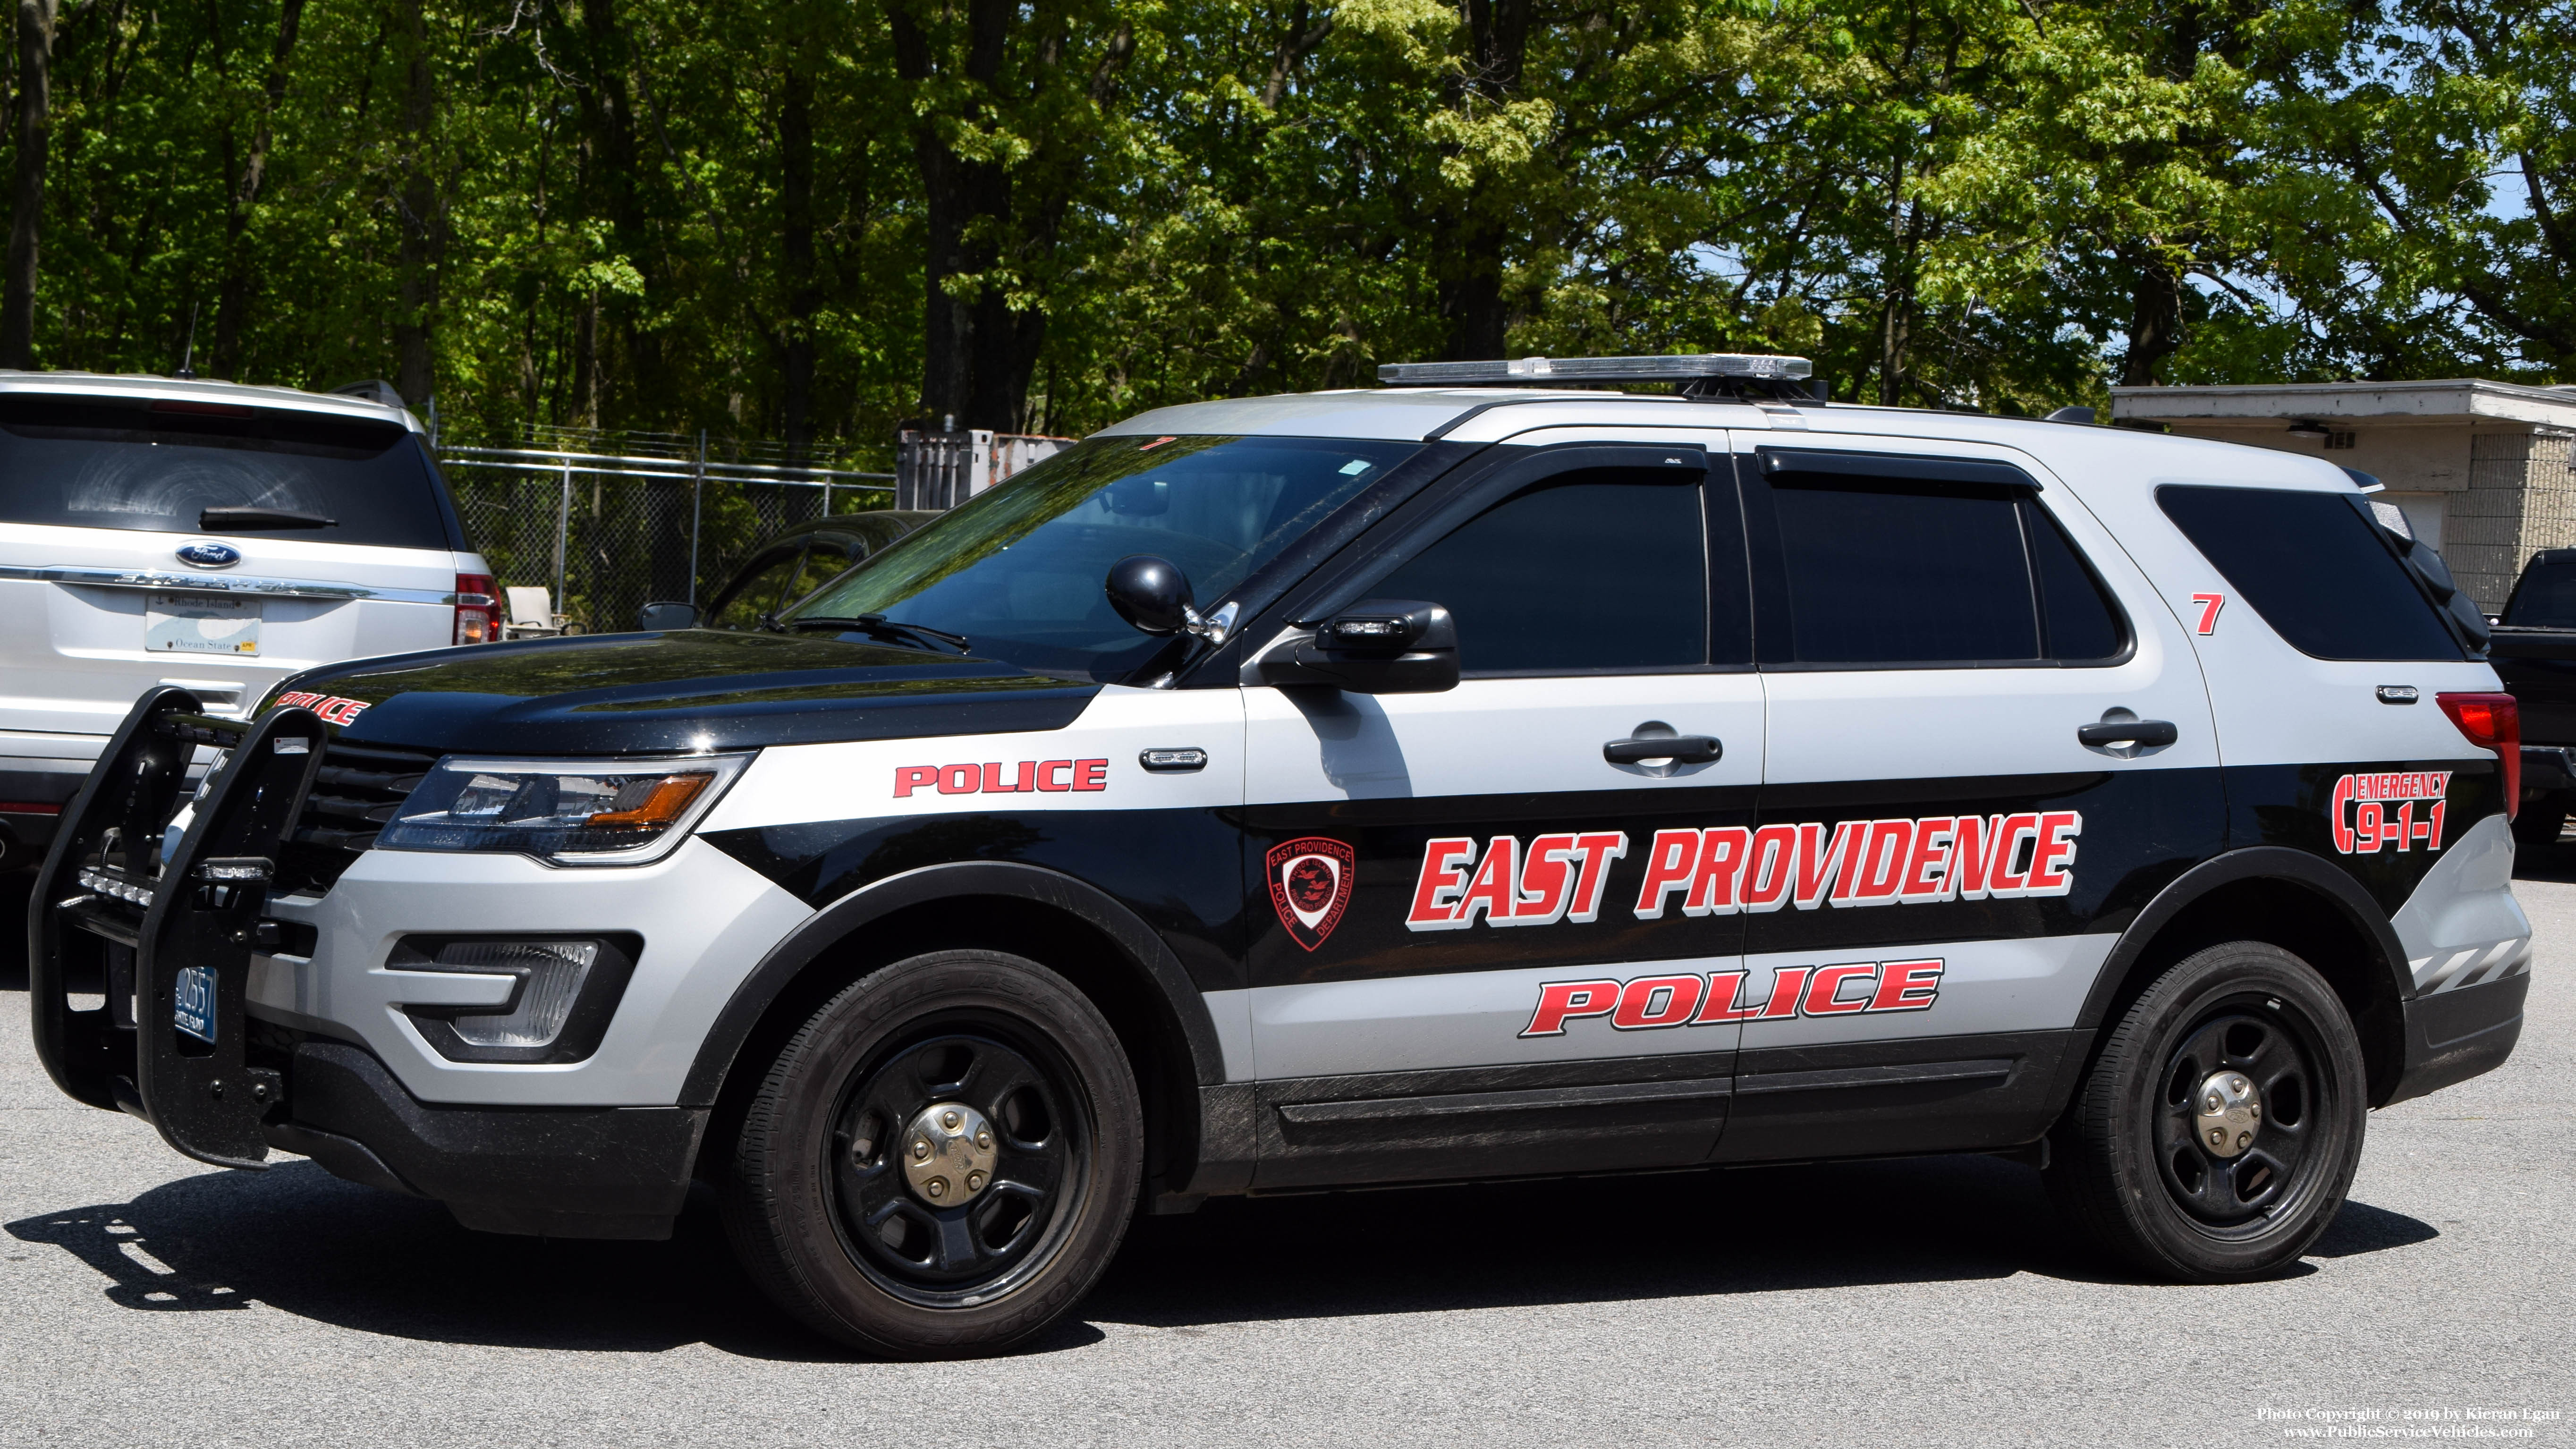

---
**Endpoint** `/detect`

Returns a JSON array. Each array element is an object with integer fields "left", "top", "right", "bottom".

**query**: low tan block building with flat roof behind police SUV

[{"left": 2110, "top": 376, "right": 2576, "bottom": 614}]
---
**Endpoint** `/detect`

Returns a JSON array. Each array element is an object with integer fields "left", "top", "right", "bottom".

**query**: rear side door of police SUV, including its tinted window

[{"left": 1721, "top": 436, "right": 2223, "bottom": 1160}]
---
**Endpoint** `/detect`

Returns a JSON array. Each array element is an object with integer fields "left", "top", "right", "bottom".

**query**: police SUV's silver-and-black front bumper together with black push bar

[{"left": 28, "top": 688, "right": 812, "bottom": 1181}]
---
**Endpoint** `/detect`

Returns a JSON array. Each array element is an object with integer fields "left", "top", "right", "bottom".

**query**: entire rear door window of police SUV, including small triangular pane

[{"left": 1764, "top": 459, "right": 2128, "bottom": 665}]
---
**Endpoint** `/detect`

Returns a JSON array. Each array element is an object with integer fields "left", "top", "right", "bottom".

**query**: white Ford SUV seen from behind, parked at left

[{"left": 0, "top": 374, "right": 497, "bottom": 864}]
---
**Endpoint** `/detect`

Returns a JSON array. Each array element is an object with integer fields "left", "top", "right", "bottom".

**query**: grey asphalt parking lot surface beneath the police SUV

[{"left": 0, "top": 846, "right": 2576, "bottom": 1449}]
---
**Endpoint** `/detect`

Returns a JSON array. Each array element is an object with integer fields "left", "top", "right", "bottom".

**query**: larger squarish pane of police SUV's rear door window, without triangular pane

[{"left": 1770, "top": 475, "right": 2040, "bottom": 665}]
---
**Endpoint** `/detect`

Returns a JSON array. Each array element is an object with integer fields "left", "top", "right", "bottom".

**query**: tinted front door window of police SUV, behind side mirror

[{"left": 1371, "top": 469, "right": 1708, "bottom": 673}]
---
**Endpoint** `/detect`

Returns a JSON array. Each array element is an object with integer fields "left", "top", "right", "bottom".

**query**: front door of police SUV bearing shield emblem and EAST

[{"left": 1244, "top": 446, "right": 1762, "bottom": 1186}]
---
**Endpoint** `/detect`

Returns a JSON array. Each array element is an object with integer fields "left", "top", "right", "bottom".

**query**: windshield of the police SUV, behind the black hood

[{"left": 788, "top": 436, "right": 1422, "bottom": 681}]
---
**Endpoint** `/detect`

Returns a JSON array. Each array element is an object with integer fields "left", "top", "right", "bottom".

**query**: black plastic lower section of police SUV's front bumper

[{"left": 265, "top": 1039, "right": 706, "bottom": 1237}]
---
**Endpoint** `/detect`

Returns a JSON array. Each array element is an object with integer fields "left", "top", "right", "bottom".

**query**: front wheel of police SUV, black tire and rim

[{"left": 721, "top": 951, "right": 1144, "bottom": 1359}]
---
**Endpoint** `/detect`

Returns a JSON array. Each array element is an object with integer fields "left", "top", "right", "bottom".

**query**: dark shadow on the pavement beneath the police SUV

[{"left": 5, "top": 1158, "right": 2437, "bottom": 1361}]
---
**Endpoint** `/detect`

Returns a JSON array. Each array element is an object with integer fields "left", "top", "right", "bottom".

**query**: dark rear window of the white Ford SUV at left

[{"left": 0, "top": 392, "right": 451, "bottom": 549}]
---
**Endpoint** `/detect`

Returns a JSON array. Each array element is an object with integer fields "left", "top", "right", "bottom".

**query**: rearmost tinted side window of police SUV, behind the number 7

[{"left": 2156, "top": 485, "right": 2463, "bottom": 660}]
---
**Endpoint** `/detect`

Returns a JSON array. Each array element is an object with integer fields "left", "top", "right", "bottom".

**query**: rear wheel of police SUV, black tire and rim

[{"left": 2048, "top": 941, "right": 2367, "bottom": 1284}]
